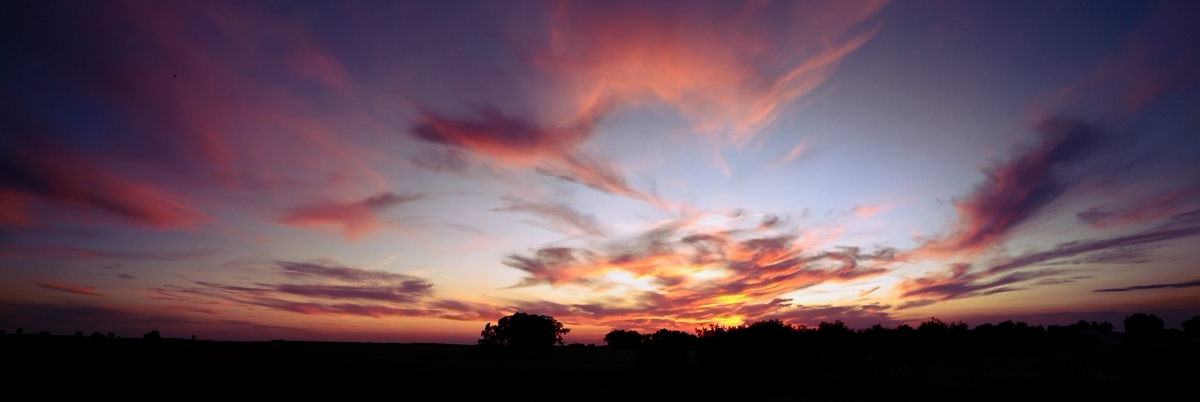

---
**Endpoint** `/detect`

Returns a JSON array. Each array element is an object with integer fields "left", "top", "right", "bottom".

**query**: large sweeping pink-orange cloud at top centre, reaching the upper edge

[{"left": 412, "top": 1, "right": 883, "bottom": 205}]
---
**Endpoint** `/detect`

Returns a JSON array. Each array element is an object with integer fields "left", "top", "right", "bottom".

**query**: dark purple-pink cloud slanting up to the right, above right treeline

[{"left": 911, "top": 119, "right": 1097, "bottom": 257}]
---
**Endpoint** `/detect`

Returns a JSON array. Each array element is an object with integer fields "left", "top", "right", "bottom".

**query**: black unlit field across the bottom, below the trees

[{"left": 0, "top": 335, "right": 1200, "bottom": 401}]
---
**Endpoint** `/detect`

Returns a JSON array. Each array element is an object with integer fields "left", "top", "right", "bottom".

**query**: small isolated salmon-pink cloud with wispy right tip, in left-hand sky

[{"left": 278, "top": 192, "right": 422, "bottom": 240}]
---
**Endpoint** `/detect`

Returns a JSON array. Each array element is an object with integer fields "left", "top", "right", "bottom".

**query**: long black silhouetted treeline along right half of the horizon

[{"left": 604, "top": 313, "right": 1200, "bottom": 366}]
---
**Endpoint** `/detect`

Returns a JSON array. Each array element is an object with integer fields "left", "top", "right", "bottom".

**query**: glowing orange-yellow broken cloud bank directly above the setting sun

[{"left": 492, "top": 214, "right": 895, "bottom": 328}]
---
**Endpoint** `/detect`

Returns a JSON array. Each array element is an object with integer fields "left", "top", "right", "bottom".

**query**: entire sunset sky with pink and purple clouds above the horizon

[{"left": 0, "top": 0, "right": 1200, "bottom": 343}]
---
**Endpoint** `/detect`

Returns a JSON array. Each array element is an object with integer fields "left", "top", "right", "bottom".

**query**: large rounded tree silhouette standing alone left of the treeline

[{"left": 479, "top": 312, "right": 571, "bottom": 349}]
